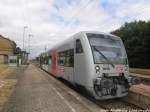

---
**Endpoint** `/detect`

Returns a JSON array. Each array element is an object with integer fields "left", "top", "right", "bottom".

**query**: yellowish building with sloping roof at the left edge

[{"left": 0, "top": 35, "right": 16, "bottom": 63}]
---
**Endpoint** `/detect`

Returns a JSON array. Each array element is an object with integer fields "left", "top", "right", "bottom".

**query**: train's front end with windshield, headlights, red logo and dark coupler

[{"left": 87, "top": 33, "right": 140, "bottom": 100}]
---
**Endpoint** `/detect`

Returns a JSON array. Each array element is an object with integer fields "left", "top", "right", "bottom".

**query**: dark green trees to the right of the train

[{"left": 111, "top": 21, "right": 150, "bottom": 68}]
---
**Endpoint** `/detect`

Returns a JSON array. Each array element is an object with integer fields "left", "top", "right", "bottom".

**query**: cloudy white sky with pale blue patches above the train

[{"left": 0, "top": 0, "right": 150, "bottom": 57}]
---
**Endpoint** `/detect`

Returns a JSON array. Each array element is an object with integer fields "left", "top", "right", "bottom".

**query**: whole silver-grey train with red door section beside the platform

[{"left": 40, "top": 31, "right": 139, "bottom": 99}]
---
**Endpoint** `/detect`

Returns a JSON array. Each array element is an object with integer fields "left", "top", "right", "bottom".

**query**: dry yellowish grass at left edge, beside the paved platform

[{"left": 0, "top": 65, "right": 17, "bottom": 111}]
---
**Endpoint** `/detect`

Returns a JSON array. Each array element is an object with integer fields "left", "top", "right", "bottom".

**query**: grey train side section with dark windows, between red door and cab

[{"left": 57, "top": 41, "right": 74, "bottom": 83}]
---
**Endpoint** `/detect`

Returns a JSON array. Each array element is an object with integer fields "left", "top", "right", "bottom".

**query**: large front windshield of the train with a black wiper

[{"left": 87, "top": 34, "right": 127, "bottom": 65}]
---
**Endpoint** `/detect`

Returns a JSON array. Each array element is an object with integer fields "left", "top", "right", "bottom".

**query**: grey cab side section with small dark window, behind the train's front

[{"left": 74, "top": 39, "right": 85, "bottom": 85}]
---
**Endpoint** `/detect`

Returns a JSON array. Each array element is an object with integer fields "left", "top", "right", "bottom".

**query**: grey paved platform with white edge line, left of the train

[{"left": 3, "top": 65, "right": 101, "bottom": 112}]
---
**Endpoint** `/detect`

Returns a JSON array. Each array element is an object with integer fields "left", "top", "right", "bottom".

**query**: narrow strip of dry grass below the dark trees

[{"left": 129, "top": 68, "right": 150, "bottom": 75}]
